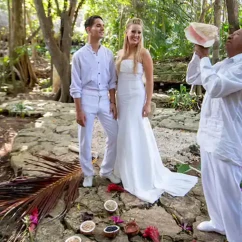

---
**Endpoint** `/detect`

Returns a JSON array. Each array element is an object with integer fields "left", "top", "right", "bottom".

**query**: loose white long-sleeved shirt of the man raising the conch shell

[{"left": 187, "top": 54, "right": 242, "bottom": 166}]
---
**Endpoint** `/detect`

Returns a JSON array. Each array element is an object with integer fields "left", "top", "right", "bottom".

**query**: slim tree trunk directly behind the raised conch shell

[{"left": 212, "top": 0, "right": 222, "bottom": 64}]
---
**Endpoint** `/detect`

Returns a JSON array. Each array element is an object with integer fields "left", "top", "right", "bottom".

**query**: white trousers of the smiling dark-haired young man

[{"left": 78, "top": 90, "right": 118, "bottom": 176}]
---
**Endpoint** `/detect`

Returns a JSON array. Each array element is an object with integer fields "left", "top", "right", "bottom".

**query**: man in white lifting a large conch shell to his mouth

[{"left": 186, "top": 26, "right": 242, "bottom": 242}]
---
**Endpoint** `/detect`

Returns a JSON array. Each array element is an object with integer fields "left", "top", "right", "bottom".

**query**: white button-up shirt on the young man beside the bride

[{"left": 70, "top": 44, "right": 117, "bottom": 98}]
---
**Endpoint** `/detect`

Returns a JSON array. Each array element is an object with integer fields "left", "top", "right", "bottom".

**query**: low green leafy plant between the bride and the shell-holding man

[{"left": 168, "top": 84, "right": 202, "bottom": 111}]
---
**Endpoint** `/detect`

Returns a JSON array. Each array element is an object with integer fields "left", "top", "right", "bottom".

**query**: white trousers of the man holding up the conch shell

[{"left": 201, "top": 149, "right": 242, "bottom": 242}]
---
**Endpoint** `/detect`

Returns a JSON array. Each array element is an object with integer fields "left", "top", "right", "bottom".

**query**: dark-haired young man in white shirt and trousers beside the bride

[{"left": 70, "top": 16, "right": 121, "bottom": 187}]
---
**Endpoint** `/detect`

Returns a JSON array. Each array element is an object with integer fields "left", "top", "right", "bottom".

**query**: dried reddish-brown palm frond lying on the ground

[{"left": 0, "top": 156, "right": 86, "bottom": 240}]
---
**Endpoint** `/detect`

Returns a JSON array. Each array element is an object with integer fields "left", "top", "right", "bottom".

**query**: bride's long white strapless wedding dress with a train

[{"left": 115, "top": 59, "right": 197, "bottom": 203}]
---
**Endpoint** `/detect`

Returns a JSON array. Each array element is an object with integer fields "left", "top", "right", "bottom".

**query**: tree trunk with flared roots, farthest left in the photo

[{"left": 9, "top": 0, "right": 37, "bottom": 87}]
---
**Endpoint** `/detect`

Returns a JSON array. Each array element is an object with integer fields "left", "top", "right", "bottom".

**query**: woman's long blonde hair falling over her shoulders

[{"left": 116, "top": 18, "right": 144, "bottom": 74}]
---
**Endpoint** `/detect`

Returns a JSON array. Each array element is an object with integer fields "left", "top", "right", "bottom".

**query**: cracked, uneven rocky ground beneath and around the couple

[{"left": 0, "top": 100, "right": 225, "bottom": 242}]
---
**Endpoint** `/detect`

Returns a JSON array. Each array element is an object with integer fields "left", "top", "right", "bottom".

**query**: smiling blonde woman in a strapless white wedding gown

[{"left": 115, "top": 18, "right": 197, "bottom": 203}]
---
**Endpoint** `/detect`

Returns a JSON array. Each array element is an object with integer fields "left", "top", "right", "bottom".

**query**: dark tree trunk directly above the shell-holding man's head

[{"left": 226, "top": 0, "right": 240, "bottom": 34}]
